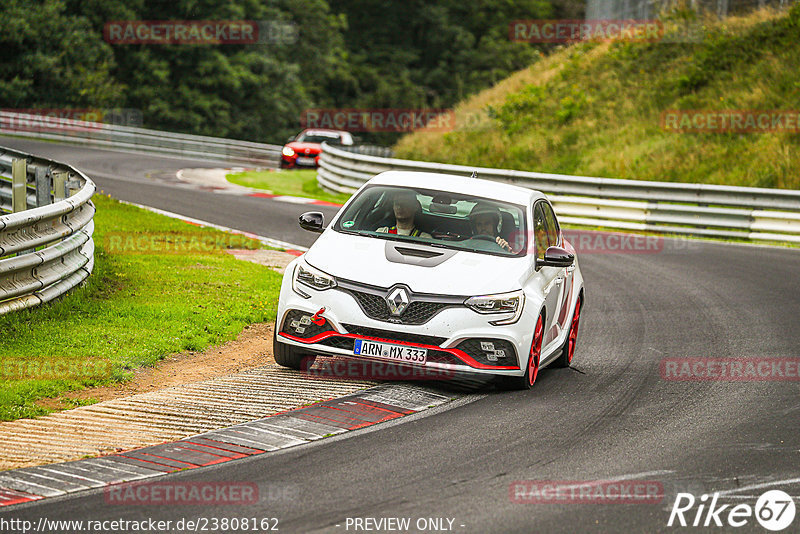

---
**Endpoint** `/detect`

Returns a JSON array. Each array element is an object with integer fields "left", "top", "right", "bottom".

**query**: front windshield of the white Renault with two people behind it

[{"left": 334, "top": 186, "right": 526, "bottom": 256}]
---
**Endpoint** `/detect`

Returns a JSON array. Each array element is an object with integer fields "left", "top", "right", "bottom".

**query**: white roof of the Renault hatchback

[{"left": 368, "top": 171, "right": 545, "bottom": 205}]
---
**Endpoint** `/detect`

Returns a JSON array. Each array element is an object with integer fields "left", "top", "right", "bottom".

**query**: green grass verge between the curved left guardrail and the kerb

[{"left": 0, "top": 195, "right": 281, "bottom": 420}]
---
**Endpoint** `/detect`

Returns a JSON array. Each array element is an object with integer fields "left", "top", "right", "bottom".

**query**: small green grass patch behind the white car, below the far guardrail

[{"left": 227, "top": 170, "right": 350, "bottom": 204}]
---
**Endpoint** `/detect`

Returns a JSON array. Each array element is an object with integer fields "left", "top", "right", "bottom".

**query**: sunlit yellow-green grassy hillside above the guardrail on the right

[{"left": 395, "top": 5, "right": 800, "bottom": 189}]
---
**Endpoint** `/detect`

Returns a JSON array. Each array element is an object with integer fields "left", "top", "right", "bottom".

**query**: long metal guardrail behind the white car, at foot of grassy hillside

[{"left": 317, "top": 144, "right": 800, "bottom": 243}]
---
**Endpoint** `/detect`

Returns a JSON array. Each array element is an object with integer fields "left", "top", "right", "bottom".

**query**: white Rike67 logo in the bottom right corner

[{"left": 667, "top": 490, "right": 796, "bottom": 532}]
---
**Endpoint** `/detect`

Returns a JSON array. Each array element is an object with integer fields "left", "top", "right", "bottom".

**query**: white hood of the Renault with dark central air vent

[{"left": 305, "top": 229, "right": 530, "bottom": 296}]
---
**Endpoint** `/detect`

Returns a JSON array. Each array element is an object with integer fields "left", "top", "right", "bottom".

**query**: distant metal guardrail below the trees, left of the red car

[{"left": 0, "top": 111, "right": 281, "bottom": 167}]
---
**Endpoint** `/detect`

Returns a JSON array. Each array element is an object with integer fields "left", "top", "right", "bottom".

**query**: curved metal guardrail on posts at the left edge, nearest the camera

[{"left": 0, "top": 147, "right": 95, "bottom": 315}]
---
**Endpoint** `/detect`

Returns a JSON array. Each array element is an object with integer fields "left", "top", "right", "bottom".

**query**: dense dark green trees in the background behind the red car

[{"left": 0, "top": 0, "right": 579, "bottom": 143}]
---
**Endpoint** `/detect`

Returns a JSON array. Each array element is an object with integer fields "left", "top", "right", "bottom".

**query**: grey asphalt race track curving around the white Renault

[{"left": 0, "top": 138, "right": 800, "bottom": 533}]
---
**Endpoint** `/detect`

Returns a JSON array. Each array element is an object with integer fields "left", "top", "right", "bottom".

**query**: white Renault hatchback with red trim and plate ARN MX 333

[{"left": 274, "top": 171, "right": 584, "bottom": 389}]
